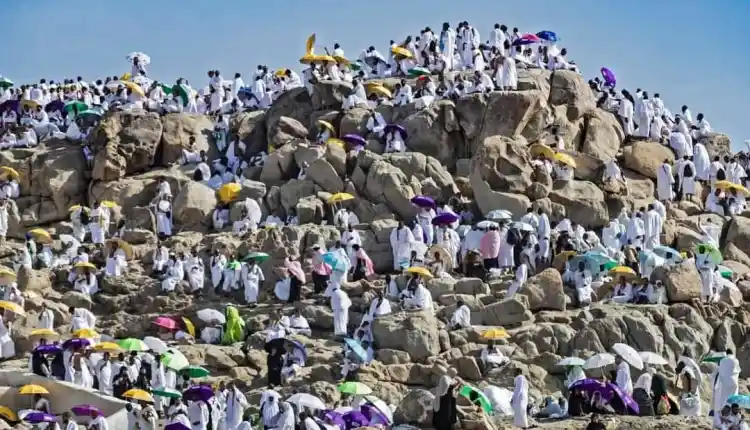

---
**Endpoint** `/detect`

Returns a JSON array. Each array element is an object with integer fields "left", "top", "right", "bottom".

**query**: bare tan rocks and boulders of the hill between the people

[{"left": 0, "top": 71, "right": 750, "bottom": 429}]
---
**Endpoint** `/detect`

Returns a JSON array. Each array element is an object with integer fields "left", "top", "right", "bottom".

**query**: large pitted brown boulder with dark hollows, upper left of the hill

[{"left": 89, "top": 111, "right": 163, "bottom": 181}]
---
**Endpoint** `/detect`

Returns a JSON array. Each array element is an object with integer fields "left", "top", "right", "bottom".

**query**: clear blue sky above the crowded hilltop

[{"left": 0, "top": 0, "right": 750, "bottom": 149}]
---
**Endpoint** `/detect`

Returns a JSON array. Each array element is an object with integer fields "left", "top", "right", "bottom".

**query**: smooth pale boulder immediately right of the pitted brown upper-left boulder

[{"left": 161, "top": 113, "right": 214, "bottom": 167}]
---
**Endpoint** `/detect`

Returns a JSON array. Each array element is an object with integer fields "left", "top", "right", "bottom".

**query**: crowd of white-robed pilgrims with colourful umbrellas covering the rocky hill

[{"left": 0, "top": 15, "right": 750, "bottom": 430}]
